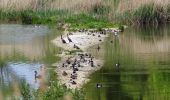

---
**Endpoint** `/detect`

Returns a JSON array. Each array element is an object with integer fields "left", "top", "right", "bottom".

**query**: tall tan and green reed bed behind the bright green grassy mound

[{"left": 0, "top": 0, "right": 170, "bottom": 24}]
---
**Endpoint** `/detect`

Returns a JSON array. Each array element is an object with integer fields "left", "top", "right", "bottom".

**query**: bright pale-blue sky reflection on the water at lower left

[{"left": 7, "top": 63, "right": 42, "bottom": 89}]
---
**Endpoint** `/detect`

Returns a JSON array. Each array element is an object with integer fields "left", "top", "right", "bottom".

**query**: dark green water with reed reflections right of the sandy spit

[{"left": 84, "top": 26, "right": 170, "bottom": 100}]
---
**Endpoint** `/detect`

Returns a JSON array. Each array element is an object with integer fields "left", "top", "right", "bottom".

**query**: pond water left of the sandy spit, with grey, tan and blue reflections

[{"left": 0, "top": 24, "right": 59, "bottom": 100}]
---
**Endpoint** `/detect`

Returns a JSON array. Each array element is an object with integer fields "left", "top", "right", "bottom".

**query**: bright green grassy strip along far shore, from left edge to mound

[{"left": 0, "top": 10, "right": 118, "bottom": 28}]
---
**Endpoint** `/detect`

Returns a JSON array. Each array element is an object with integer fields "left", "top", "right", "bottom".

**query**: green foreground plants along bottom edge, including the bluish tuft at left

[{"left": 20, "top": 70, "right": 84, "bottom": 100}]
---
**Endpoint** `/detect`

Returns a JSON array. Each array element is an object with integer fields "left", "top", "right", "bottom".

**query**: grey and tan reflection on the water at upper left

[{"left": 0, "top": 25, "right": 49, "bottom": 58}]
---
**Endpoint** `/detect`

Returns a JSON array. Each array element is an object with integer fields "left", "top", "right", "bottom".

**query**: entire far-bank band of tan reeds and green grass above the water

[{"left": 0, "top": 0, "right": 170, "bottom": 25}]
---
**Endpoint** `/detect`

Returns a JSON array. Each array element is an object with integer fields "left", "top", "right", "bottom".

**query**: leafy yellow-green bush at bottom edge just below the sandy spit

[{"left": 34, "top": 70, "right": 84, "bottom": 100}]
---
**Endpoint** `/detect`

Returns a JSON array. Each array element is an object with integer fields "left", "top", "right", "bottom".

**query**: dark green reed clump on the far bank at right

[{"left": 118, "top": 3, "right": 170, "bottom": 24}]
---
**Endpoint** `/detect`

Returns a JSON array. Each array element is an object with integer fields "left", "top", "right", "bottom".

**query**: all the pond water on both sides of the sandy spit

[{"left": 0, "top": 24, "right": 170, "bottom": 100}]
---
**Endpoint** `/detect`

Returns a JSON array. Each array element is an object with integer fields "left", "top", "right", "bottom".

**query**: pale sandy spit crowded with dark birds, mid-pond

[{"left": 52, "top": 28, "right": 118, "bottom": 89}]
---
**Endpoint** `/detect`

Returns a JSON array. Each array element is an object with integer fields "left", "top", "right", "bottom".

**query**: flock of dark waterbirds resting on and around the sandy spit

[{"left": 61, "top": 29, "right": 120, "bottom": 88}]
